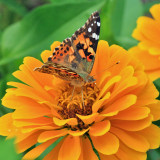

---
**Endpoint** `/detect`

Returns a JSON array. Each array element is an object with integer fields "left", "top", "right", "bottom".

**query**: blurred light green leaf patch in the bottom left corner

[{"left": 0, "top": 138, "right": 21, "bottom": 160}]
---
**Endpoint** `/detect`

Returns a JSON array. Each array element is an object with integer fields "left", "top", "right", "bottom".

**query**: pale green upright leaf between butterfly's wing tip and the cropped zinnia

[{"left": 106, "top": 0, "right": 143, "bottom": 48}]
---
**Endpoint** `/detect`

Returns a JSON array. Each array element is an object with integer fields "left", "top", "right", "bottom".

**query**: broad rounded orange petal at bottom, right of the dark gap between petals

[{"left": 91, "top": 132, "right": 119, "bottom": 155}]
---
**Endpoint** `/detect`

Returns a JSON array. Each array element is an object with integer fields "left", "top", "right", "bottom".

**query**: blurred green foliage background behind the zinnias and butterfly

[{"left": 0, "top": 0, "right": 160, "bottom": 160}]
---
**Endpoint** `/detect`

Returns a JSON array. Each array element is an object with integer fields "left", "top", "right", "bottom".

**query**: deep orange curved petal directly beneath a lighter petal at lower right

[{"left": 111, "top": 116, "right": 153, "bottom": 131}]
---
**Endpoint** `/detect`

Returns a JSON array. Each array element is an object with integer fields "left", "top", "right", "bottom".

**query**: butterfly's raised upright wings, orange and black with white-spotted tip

[{"left": 35, "top": 12, "right": 100, "bottom": 81}]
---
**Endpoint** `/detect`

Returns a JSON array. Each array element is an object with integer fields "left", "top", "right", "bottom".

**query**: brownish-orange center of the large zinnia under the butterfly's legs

[{"left": 58, "top": 83, "right": 99, "bottom": 130}]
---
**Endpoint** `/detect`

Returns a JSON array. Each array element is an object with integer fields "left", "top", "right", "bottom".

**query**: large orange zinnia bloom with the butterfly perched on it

[{"left": 0, "top": 41, "right": 160, "bottom": 160}]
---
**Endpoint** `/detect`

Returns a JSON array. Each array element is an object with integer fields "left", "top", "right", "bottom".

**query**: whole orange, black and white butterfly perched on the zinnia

[{"left": 35, "top": 12, "right": 100, "bottom": 85}]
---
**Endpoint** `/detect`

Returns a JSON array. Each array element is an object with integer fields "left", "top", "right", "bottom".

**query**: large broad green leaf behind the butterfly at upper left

[{"left": 0, "top": 0, "right": 104, "bottom": 65}]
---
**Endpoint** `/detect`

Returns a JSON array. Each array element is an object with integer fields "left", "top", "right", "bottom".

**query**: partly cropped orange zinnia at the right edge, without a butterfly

[{"left": 130, "top": 4, "right": 160, "bottom": 80}]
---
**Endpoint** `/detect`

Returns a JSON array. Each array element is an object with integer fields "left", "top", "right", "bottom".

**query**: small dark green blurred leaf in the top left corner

[{"left": 0, "top": 0, "right": 27, "bottom": 16}]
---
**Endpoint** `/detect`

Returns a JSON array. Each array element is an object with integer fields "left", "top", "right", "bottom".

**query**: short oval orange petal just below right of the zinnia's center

[{"left": 89, "top": 120, "right": 111, "bottom": 136}]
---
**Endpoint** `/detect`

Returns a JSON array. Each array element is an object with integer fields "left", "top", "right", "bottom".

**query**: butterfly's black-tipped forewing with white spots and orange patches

[{"left": 71, "top": 12, "right": 100, "bottom": 79}]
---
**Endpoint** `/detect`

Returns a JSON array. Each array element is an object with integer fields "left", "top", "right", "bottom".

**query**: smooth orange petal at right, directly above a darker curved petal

[{"left": 112, "top": 107, "right": 150, "bottom": 120}]
